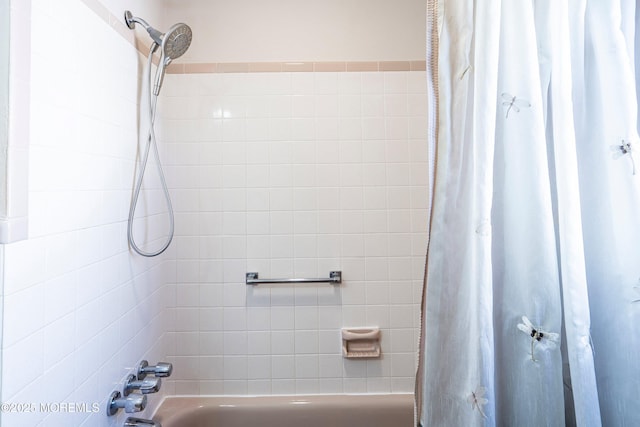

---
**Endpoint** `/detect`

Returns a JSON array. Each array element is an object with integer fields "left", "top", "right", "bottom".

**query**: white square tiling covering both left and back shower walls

[{"left": 0, "top": 0, "right": 427, "bottom": 427}]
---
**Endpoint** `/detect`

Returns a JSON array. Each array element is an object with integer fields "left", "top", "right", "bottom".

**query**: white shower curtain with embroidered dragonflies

[{"left": 416, "top": 0, "right": 640, "bottom": 427}]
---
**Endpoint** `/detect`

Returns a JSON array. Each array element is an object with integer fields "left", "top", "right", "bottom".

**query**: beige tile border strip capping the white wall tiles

[{"left": 82, "top": 0, "right": 426, "bottom": 74}]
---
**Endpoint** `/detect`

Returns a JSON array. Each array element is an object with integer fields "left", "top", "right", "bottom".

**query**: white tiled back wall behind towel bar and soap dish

[{"left": 160, "top": 72, "right": 427, "bottom": 394}]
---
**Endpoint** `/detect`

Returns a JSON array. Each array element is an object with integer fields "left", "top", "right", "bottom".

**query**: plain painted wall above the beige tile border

[{"left": 165, "top": 0, "right": 426, "bottom": 62}]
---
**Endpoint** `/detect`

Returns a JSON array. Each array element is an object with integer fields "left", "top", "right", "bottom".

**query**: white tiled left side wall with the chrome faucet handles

[{"left": 0, "top": 0, "right": 175, "bottom": 427}]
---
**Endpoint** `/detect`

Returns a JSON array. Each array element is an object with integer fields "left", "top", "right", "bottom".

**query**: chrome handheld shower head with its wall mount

[{"left": 124, "top": 10, "right": 193, "bottom": 96}]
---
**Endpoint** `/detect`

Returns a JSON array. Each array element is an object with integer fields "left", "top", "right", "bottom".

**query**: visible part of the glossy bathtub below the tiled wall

[{"left": 153, "top": 394, "right": 413, "bottom": 427}]
